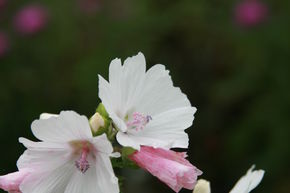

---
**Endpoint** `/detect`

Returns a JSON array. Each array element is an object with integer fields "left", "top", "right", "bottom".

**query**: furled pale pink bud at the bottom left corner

[{"left": 0, "top": 170, "right": 29, "bottom": 193}]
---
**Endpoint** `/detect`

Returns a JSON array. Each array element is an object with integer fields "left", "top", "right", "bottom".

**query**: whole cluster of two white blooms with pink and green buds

[{"left": 0, "top": 53, "right": 264, "bottom": 193}]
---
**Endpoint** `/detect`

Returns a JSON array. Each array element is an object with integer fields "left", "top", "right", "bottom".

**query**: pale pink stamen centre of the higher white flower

[{"left": 126, "top": 112, "right": 152, "bottom": 131}]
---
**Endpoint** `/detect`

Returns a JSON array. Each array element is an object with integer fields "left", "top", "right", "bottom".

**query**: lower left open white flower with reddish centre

[{"left": 17, "top": 111, "right": 119, "bottom": 193}]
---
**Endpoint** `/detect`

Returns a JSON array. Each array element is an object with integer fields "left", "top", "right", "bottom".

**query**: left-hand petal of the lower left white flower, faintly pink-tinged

[{"left": 17, "top": 138, "right": 76, "bottom": 193}]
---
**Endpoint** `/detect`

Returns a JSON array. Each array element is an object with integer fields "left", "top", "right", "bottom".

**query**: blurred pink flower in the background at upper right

[{"left": 235, "top": 0, "right": 268, "bottom": 27}]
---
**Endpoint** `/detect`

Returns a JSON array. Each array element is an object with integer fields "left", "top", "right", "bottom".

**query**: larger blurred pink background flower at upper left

[{"left": 14, "top": 5, "right": 48, "bottom": 35}]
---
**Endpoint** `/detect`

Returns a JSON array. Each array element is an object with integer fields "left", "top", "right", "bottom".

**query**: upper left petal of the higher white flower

[{"left": 99, "top": 53, "right": 146, "bottom": 131}]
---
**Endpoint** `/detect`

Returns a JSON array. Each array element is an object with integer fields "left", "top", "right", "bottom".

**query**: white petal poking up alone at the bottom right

[{"left": 230, "top": 166, "right": 265, "bottom": 193}]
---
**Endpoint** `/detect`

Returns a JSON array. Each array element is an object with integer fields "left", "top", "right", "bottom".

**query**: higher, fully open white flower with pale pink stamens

[{"left": 99, "top": 53, "right": 196, "bottom": 150}]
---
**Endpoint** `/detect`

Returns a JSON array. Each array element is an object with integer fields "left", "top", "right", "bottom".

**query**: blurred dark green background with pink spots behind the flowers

[{"left": 0, "top": 0, "right": 290, "bottom": 193}]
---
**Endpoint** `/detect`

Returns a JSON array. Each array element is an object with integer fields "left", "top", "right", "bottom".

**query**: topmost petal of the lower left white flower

[{"left": 31, "top": 111, "right": 92, "bottom": 142}]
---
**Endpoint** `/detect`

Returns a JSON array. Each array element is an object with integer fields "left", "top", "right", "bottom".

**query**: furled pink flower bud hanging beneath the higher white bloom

[{"left": 129, "top": 146, "right": 202, "bottom": 192}]
